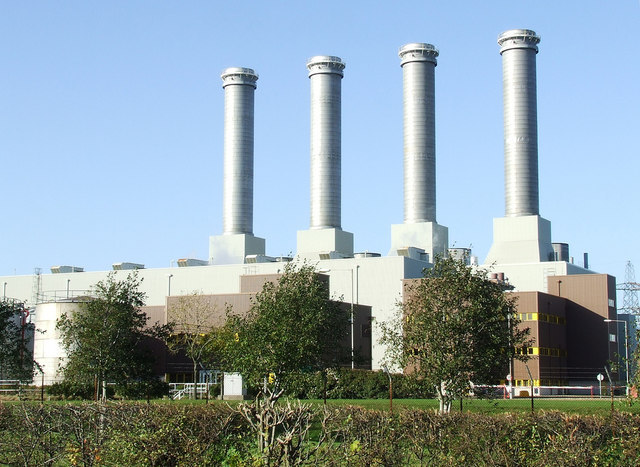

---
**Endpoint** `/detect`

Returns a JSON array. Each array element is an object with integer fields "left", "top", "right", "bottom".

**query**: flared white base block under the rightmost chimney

[{"left": 484, "top": 216, "right": 553, "bottom": 266}]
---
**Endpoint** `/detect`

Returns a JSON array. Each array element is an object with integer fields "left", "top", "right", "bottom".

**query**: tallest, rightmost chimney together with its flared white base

[{"left": 484, "top": 29, "right": 552, "bottom": 268}]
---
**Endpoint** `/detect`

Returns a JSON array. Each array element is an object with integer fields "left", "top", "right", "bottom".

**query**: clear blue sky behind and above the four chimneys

[{"left": 0, "top": 0, "right": 640, "bottom": 288}]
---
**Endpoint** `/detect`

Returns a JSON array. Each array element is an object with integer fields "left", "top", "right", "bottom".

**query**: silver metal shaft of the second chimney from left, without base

[{"left": 307, "top": 55, "right": 345, "bottom": 229}]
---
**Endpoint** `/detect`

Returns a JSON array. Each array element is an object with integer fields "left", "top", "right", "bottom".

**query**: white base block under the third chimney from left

[{"left": 389, "top": 222, "right": 449, "bottom": 263}]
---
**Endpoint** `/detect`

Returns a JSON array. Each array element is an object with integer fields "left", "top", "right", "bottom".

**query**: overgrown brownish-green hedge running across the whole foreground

[{"left": 0, "top": 403, "right": 640, "bottom": 466}]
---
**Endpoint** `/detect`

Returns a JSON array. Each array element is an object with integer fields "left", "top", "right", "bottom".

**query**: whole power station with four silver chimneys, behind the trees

[{"left": 0, "top": 29, "right": 624, "bottom": 394}]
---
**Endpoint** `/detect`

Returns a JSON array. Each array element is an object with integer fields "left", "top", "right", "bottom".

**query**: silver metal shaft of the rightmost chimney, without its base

[{"left": 498, "top": 29, "right": 540, "bottom": 217}]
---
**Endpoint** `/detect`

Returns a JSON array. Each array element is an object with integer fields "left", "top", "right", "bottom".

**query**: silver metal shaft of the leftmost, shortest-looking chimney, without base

[{"left": 220, "top": 67, "right": 258, "bottom": 235}]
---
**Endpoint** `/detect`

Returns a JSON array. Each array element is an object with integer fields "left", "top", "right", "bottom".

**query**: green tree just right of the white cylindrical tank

[{"left": 56, "top": 272, "right": 165, "bottom": 394}]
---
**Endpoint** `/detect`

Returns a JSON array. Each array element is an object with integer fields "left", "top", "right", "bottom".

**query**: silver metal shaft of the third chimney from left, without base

[{"left": 398, "top": 43, "right": 438, "bottom": 224}]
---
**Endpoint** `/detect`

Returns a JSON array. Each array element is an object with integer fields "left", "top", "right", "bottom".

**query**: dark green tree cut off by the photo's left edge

[{"left": 0, "top": 299, "right": 35, "bottom": 381}]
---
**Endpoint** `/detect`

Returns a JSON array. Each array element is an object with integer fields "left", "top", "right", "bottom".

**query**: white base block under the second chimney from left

[{"left": 296, "top": 228, "right": 353, "bottom": 260}]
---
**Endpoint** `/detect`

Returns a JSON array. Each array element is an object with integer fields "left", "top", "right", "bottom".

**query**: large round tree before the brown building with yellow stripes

[{"left": 381, "top": 258, "right": 529, "bottom": 412}]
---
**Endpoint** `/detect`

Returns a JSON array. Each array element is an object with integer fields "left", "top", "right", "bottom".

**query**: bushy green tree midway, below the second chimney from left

[{"left": 225, "top": 263, "right": 349, "bottom": 394}]
